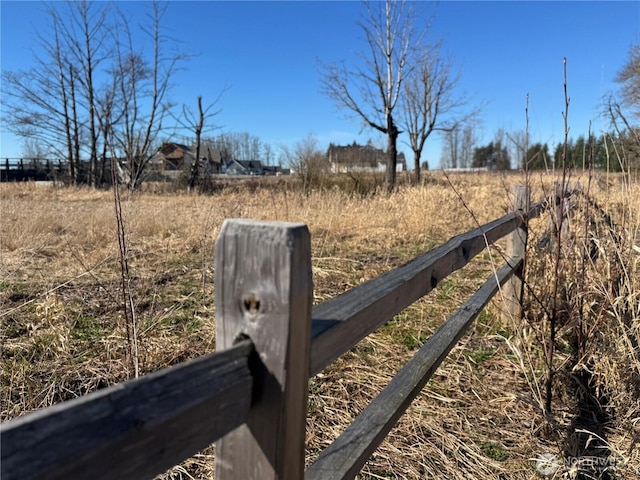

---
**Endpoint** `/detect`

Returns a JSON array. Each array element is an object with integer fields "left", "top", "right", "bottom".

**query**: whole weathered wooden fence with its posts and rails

[{"left": 0, "top": 187, "right": 560, "bottom": 480}]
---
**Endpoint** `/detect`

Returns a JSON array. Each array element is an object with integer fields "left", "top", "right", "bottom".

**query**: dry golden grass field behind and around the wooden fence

[{"left": 0, "top": 172, "right": 640, "bottom": 479}]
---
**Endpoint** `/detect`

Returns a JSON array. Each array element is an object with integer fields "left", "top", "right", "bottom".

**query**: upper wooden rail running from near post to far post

[{"left": 309, "top": 202, "right": 543, "bottom": 376}]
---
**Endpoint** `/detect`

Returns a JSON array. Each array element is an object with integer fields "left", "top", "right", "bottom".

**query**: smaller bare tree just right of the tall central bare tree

[{"left": 401, "top": 42, "right": 477, "bottom": 183}]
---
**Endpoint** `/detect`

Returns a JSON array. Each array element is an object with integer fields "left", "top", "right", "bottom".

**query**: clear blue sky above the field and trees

[{"left": 0, "top": 0, "right": 640, "bottom": 167}]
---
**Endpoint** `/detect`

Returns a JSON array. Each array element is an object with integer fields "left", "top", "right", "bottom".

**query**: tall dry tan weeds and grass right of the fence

[{"left": 518, "top": 172, "right": 640, "bottom": 478}]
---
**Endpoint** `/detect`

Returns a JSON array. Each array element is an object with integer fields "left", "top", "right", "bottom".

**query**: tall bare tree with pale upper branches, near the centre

[{"left": 321, "top": 0, "right": 421, "bottom": 192}]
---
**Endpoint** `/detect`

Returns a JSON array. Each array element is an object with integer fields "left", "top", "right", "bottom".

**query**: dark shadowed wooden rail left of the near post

[{"left": 0, "top": 341, "right": 253, "bottom": 480}]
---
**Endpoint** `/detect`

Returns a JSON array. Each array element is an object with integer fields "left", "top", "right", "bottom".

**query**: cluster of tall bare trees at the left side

[{"left": 2, "top": 0, "right": 186, "bottom": 188}]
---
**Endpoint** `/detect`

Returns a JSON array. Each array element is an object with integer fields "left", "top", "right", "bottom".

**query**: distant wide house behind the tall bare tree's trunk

[{"left": 327, "top": 142, "right": 407, "bottom": 173}]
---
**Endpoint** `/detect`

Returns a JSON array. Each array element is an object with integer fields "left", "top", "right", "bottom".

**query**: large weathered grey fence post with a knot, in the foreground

[{"left": 215, "top": 219, "right": 313, "bottom": 480}]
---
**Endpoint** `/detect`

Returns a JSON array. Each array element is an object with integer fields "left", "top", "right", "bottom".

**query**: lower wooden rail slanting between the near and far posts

[{"left": 305, "top": 262, "right": 521, "bottom": 480}]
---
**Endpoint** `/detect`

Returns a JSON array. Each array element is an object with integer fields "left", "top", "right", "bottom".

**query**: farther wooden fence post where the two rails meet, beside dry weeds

[{"left": 505, "top": 185, "right": 531, "bottom": 325}]
